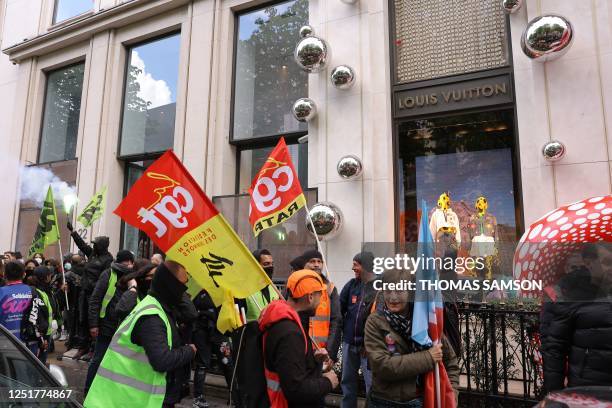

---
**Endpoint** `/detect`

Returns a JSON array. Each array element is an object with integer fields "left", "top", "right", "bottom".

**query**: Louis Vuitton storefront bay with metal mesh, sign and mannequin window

[{"left": 390, "top": 0, "right": 523, "bottom": 258}]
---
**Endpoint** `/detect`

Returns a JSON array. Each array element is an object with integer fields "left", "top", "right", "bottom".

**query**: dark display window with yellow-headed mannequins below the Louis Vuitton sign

[{"left": 397, "top": 110, "right": 520, "bottom": 247}]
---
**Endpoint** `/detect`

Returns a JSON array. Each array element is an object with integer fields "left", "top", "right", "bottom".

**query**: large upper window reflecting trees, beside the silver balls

[{"left": 232, "top": 0, "right": 308, "bottom": 141}]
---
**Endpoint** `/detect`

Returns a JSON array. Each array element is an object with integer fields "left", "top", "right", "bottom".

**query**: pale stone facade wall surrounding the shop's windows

[{"left": 0, "top": 0, "right": 612, "bottom": 283}]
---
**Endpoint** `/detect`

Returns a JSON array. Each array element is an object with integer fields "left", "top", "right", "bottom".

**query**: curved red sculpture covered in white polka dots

[{"left": 513, "top": 195, "right": 612, "bottom": 297}]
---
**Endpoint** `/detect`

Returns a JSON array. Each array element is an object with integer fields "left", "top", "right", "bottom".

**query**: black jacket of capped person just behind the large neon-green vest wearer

[{"left": 87, "top": 269, "right": 123, "bottom": 337}]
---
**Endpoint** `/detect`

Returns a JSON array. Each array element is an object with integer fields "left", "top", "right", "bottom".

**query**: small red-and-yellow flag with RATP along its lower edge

[{"left": 249, "top": 137, "right": 306, "bottom": 236}]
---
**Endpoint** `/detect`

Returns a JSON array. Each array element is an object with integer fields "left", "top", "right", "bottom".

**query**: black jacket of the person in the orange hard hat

[{"left": 264, "top": 316, "right": 332, "bottom": 408}]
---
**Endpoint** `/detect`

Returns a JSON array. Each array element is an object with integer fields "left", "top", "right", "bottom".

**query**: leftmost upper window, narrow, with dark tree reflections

[{"left": 38, "top": 63, "right": 85, "bottom": 163}]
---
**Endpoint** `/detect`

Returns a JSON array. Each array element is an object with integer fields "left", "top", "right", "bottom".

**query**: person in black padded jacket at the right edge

[{"left": 540, "top": 243, "right": 612, "bottom": 392}]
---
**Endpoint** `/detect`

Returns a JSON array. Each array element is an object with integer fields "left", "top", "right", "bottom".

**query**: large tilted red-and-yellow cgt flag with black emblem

[{"left": 114, "top": 150, "right": 271, "bottom": 332}]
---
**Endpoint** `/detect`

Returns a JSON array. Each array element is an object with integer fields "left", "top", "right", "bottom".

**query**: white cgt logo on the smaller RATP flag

[{"left": 249, "top": 158, "right": 294, "bottom": 213}]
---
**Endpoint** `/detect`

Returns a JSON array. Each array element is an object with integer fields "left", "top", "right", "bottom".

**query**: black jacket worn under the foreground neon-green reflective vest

[{"left": 132, "top": 296, "right": 194, "bottom": 404}]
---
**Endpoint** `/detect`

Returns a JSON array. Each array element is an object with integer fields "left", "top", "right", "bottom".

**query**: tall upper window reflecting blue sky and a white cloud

[{"left": 119, "top": 34, "right": 180, "bottom": 157}]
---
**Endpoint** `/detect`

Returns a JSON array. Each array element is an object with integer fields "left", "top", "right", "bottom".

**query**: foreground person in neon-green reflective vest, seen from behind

[{"left": 84, "top": 261, "right": 196, "bottom": 408}]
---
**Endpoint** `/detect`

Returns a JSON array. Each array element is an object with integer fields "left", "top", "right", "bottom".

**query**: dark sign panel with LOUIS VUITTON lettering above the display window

[{"left": 393, "top": 75, "right": 513, "bottom": 117}]
